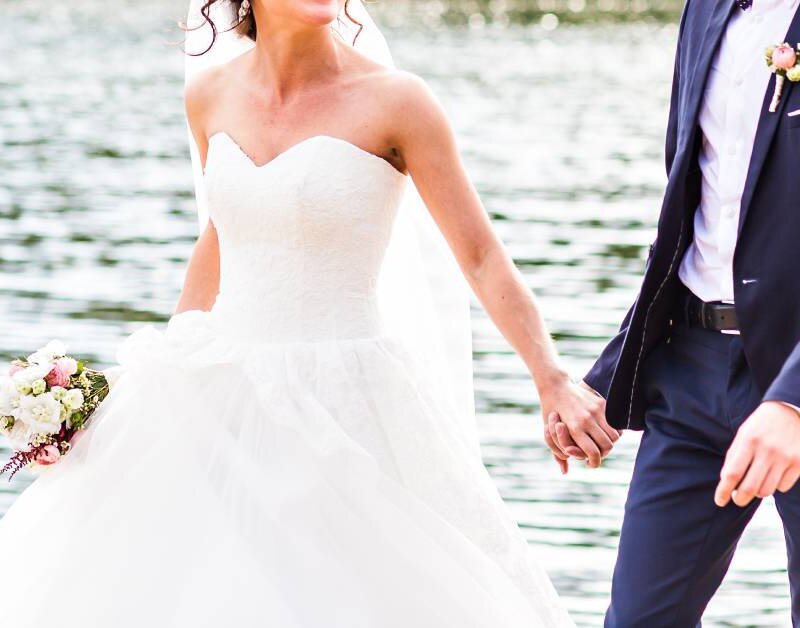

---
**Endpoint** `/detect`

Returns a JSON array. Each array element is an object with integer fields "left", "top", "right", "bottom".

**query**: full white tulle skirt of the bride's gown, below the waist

[{"left": 0, "top": 312, "right": 572, "bottom": 628}]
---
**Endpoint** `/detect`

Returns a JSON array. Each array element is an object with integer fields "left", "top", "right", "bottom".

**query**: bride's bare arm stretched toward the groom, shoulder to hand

[{"left": 390, "top": 75, "right": 619, "bottom": 468}]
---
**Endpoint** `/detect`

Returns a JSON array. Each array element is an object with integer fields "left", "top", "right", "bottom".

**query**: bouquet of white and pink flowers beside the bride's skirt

[{"left": 0, "top": 340, "right": 109, "bottom": 480}]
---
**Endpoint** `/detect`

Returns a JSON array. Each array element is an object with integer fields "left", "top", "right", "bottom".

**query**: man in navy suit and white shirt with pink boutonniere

[{"left": 553, "top": 0, "right": 800, "bottom": 628}]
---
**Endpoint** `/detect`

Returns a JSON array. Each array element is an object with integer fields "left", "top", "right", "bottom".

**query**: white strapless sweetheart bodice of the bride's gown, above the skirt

[{"left": 205, "top": 133, "right": 406, "bottom": 341}]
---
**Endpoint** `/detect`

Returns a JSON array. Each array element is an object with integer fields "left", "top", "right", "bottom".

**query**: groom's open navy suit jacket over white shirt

[{"left": 585, "top": 0, "right": 800, "bottom": 429}]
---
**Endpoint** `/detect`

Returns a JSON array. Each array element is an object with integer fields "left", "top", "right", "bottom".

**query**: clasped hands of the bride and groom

[{"left": 541, "top": 381, "right": 620, "bottom": 472}]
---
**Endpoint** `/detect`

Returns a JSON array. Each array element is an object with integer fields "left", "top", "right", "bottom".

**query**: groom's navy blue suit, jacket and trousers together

[{"left": 585, "top": 0, "right": 800, "bottom": 628}]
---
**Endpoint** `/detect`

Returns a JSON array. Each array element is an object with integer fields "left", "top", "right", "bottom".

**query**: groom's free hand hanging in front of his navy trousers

[{"left": 714, "top": 401, "right": 800, "bottom": 507}]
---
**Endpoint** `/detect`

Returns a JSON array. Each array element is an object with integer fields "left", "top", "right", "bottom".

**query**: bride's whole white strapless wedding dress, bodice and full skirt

[{"left": 0, "top": 134, "right": 573, "bottom": 628}]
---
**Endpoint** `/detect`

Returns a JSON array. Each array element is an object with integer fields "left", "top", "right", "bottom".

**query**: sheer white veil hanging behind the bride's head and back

[{"left": 185, "top": 0, "right": 480, "bottom": 456}]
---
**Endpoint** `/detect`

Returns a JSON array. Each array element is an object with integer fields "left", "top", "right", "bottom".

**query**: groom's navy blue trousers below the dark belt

[{"left": 605, "top": 326, "right": 800, "bottom": 628}]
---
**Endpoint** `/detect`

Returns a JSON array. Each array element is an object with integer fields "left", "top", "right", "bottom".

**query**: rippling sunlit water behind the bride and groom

[{"left": 0, "top": 0, "right": 790, "bottom": 627}]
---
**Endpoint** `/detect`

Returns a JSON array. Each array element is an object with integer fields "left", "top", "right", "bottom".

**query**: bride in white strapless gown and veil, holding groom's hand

[{"left": 0, "top": 0, "right": 617, "bottom": 628}]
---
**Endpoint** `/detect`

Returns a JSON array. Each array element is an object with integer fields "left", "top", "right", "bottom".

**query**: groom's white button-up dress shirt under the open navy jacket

[{"left": 678, "top": 0, "right": 800, "bottom": 301}]
